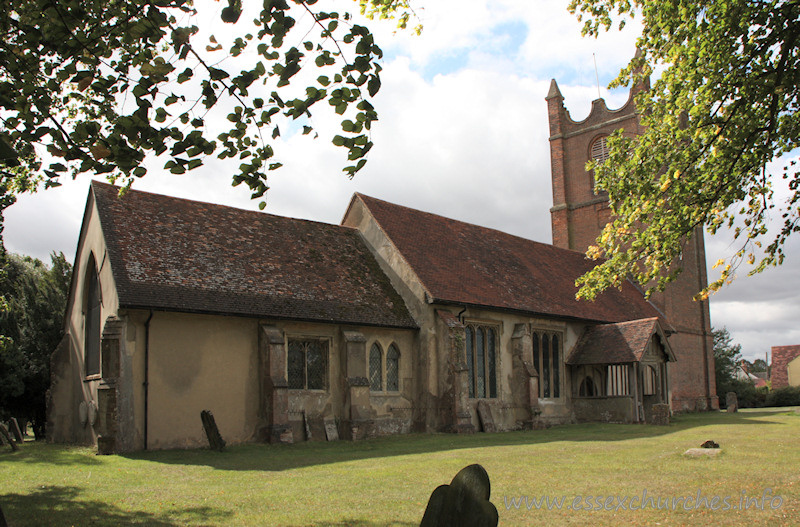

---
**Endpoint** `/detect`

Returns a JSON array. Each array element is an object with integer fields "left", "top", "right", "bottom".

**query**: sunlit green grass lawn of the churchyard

[{"left": 0, "top": 408, "right": 800, "bottom": 527}]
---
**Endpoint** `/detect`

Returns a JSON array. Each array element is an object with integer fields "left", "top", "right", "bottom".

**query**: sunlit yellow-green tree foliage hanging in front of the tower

[{"left": 569, "top": 0, "right": 800, "bottom": 298}]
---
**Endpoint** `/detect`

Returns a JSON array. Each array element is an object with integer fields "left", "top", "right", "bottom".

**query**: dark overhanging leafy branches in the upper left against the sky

[{"left": 0, "top": 0, "right": 413, "bottom": 212}]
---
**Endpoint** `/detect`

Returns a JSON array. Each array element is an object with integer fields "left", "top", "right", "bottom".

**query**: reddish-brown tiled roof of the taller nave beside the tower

[{"left": 354, "top": 194, "right": 660, "bottom": 322}]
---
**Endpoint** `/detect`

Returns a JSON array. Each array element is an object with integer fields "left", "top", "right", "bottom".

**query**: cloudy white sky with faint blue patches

[{"left": 3, "top": 0, "right": 800, "bottom": 361}]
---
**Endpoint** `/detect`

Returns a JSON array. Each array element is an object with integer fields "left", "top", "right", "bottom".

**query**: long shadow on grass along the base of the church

[{"left": 126, "top": 411, "right": 782, "bottom": 471}]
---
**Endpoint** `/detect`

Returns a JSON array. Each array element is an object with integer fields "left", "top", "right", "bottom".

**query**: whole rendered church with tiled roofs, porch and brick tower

[{"left": 48, "top": 81, "right": 716, "bottom": 452}]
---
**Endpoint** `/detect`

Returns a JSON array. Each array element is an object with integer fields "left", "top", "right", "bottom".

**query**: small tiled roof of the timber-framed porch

[{"left": 566, "top": 318, "right": 674, "bottom": 364}]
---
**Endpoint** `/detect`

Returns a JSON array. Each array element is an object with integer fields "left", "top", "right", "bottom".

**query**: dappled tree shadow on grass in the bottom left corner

[{"left": 0, "top": 486, "right": 230, "bottom": 527}]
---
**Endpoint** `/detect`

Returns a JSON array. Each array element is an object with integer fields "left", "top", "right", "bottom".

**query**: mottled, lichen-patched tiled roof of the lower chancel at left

[{"left": 92, "top": 182, "right": 417, "bottom": 328}]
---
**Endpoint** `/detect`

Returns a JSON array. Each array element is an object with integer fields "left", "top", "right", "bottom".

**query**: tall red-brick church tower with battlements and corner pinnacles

[{"left": 546, "top": 79, "right": 719, "bottom": 411}]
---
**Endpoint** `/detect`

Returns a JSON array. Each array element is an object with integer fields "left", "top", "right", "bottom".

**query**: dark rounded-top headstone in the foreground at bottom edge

[{"left": 420, "top": 465, "right": 499, "bottom": 527}]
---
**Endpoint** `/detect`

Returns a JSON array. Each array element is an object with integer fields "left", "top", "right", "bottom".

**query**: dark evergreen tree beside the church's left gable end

[{"left": 0, "top": 253, "right": 72, "bottom": 439}]
